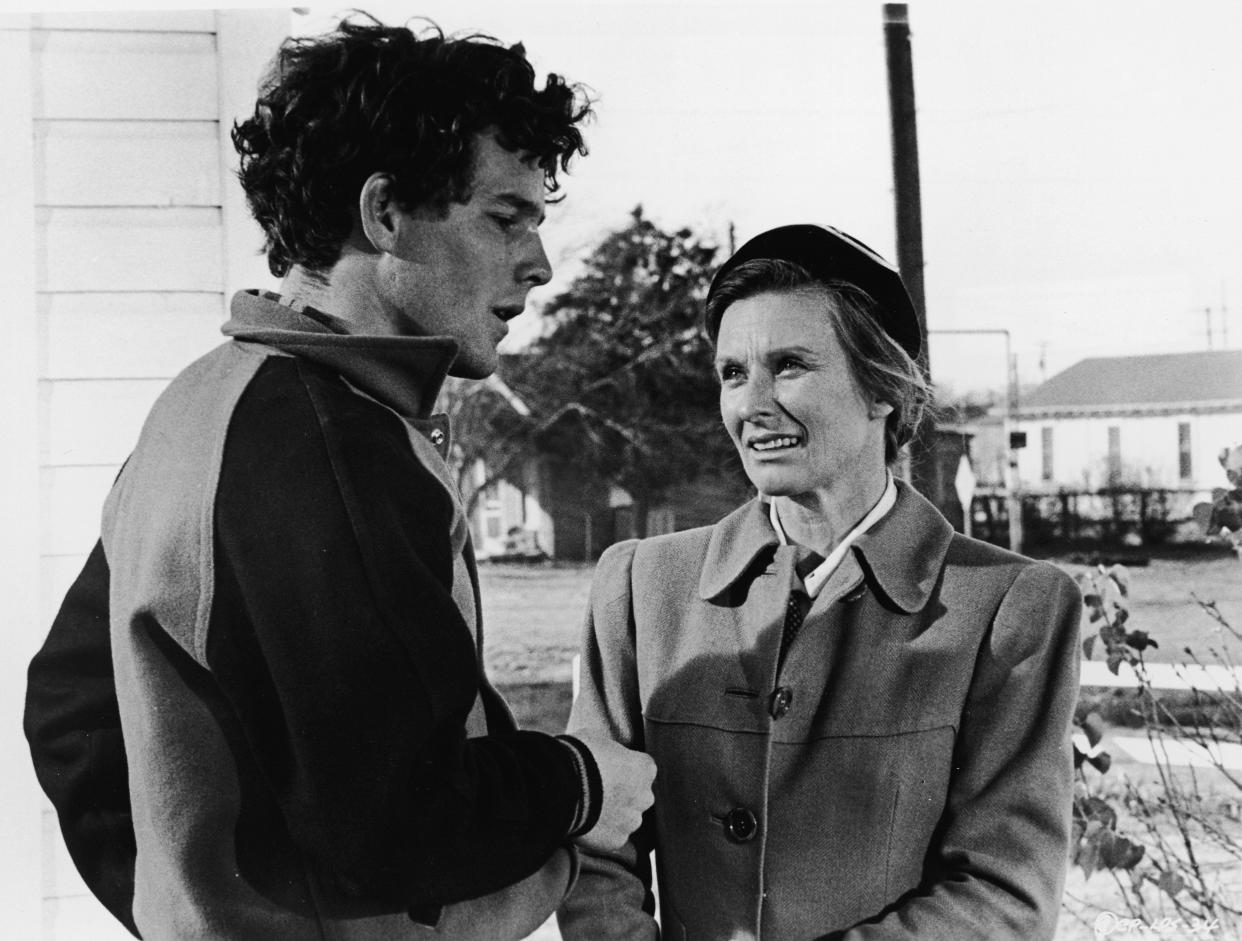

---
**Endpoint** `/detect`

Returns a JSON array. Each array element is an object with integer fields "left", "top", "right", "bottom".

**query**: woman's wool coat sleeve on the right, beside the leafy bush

[{"left": 828, "top": 562, "right": 1082, "bottom": 941}]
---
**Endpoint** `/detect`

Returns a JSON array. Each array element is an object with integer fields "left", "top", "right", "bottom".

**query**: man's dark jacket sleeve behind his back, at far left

[{"left": 24, "top": 543, "right": 138, "bottom": 936}]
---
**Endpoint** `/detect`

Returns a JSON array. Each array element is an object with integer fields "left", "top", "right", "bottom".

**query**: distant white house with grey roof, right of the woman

[{"left": 1017, "top": 350, "right": 1242, "bottom": 493}]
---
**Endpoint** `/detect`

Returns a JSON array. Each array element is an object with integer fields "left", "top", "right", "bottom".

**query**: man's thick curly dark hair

[{"left": 232, "top": 15, "right": 591, "bottom": 277}]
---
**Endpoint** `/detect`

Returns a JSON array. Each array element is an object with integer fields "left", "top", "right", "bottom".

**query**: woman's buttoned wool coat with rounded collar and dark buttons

[{"left": 560, "top": 484, "right": 1081, "bottom": 941}]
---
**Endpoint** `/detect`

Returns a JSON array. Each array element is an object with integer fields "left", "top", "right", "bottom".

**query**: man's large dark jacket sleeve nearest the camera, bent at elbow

[{"left": 206, "top": 359, "right": 581, "bottom": 906}]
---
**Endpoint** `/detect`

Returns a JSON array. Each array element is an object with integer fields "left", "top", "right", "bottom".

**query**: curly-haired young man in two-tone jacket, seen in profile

[{"left": 26, "top": 21, "right": 653, "bottom": 939}]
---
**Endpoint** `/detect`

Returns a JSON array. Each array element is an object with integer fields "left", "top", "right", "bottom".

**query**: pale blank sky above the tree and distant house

[{"left": 33, "top": 0, "right": 1242, "bottom": 391}]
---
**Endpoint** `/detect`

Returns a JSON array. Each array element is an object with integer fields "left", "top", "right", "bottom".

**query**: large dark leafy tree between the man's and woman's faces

[{"left": 458, "top": 207, "right": 745, "bottom": 526}]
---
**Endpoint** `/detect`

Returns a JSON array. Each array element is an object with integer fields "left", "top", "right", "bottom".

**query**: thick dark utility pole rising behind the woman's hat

[{"left": 884, "top": 4, "right": 944, "bottom": 504}]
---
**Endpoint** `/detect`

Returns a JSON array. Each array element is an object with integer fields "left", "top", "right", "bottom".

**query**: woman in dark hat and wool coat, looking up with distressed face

[{"left": 560, "top": 225, "right": 1079, "bottom": 941}]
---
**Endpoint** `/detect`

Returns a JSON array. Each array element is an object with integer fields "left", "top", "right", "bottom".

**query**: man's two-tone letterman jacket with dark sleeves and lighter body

[{"left": 26, "top": 293, "right": 582, "bottom": 939}]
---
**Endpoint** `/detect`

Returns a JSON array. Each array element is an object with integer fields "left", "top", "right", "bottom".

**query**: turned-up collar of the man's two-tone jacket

[{"left": 222, "top": 290, "right": 457, "bottom": 420}]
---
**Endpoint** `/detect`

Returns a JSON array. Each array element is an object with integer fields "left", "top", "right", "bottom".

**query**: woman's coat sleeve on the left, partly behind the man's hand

[{"left": 556, "top": 541, "right": 660, "bottom": 941}]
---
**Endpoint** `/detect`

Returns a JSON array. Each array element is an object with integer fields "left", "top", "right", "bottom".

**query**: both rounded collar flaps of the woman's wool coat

[{"left": 699, "top": 480, "right": 953, "bottom": 613}]
